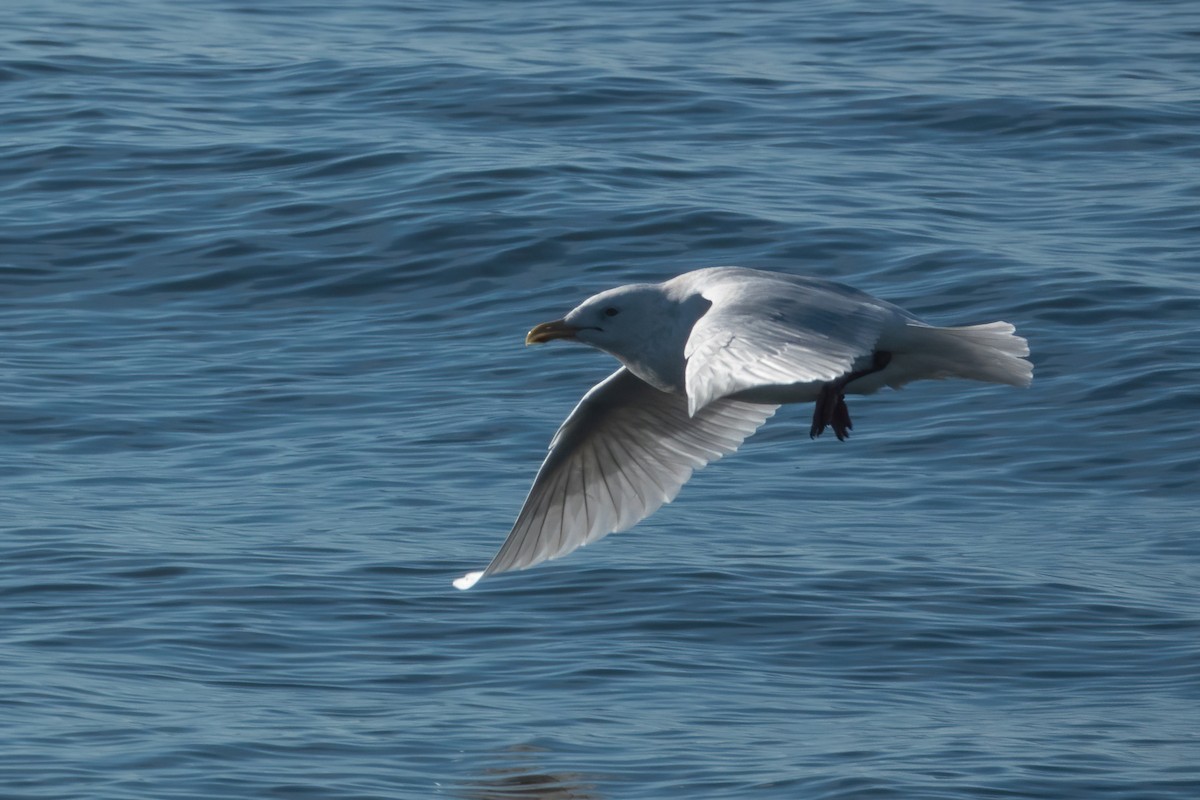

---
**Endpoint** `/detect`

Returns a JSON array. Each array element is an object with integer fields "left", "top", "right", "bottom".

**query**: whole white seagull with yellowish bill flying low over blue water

[{"left": 454, "top": 266, "right": 1033, "bottom": 589}]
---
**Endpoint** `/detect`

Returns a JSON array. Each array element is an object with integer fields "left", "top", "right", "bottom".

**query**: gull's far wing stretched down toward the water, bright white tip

[{"left": 455, "top": 367, "right": 778, "bottom": 589}]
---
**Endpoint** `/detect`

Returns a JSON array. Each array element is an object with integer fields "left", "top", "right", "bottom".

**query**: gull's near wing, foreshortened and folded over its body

[{"left": 684, "top": 270, "right": 907, "bottom": 414}]
